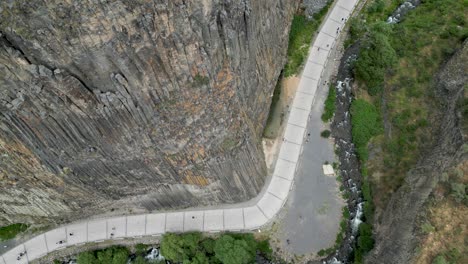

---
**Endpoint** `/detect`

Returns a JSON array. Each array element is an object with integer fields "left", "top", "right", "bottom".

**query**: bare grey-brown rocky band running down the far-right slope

[{"left": 366, "top": 40, "right": 468, "bottom": 264}]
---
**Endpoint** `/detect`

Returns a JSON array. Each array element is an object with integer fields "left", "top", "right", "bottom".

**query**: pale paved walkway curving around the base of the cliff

[{"left": 0, "top": 0, "right": 358, "bottom": 264}]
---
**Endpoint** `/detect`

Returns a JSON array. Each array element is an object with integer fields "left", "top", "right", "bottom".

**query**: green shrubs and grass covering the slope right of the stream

[{"left": 346, "top": 0, "right": 468, "bottom": 263}]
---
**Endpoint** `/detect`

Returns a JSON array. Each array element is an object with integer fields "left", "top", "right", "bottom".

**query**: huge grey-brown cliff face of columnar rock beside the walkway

[{"left": 0, "top": 0, "right": 297, "bottom": 224}]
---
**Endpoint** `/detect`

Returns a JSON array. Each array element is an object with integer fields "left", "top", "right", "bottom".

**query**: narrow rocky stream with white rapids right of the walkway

[{"left": 322, "top": 0, "right": 421, "bottom": 264}]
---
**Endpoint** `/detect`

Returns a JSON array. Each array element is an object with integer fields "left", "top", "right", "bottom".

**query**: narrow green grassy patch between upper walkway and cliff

[{"left": 284, "top": 0, "right": 333, "bottom": 77}]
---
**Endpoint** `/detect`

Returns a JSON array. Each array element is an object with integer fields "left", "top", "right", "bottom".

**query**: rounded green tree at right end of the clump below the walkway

[{"left": 214, "top": 235, "right": 256, "bottom": 264}]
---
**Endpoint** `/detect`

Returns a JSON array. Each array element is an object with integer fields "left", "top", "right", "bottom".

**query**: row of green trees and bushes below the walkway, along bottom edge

[{"left": 72, "top": 232, "right": 272, "bottom": 264}]
